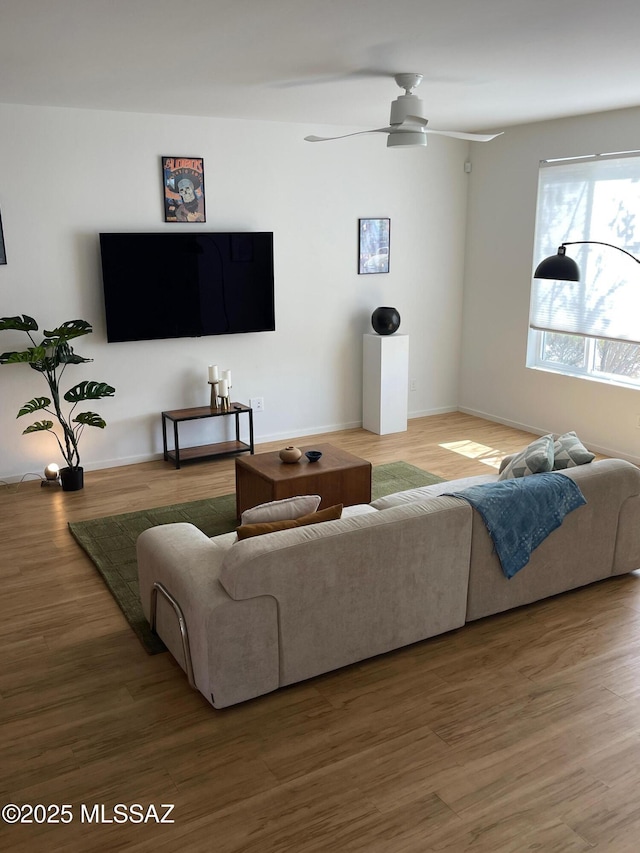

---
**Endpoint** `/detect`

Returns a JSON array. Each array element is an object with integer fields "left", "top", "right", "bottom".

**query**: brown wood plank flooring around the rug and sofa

[{"left": 0, "top": 413, "right": 640, "bottom": 853}]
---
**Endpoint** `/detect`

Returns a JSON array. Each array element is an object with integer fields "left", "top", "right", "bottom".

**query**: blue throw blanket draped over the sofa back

[{"left": 447, "top": 473, "right": 587, "bottom": 578}]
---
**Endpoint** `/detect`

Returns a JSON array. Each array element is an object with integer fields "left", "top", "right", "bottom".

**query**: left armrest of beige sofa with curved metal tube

[{"left": 137, "top": 523, "right": 279, "bottom": 708}]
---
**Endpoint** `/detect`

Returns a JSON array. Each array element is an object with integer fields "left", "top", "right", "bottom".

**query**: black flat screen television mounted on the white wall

[{"left": 100, "top": 231, "right": 275, "bottom": 342}]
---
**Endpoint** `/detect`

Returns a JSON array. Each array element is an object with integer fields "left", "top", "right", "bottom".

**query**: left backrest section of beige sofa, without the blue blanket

[{"left": 219, "top": 497, "right": 471, "bottom": 684}]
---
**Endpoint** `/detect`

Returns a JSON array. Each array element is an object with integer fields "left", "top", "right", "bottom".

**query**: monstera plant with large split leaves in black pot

[{"left": 0, "top": 314, "right": 115, "bottom": 491}]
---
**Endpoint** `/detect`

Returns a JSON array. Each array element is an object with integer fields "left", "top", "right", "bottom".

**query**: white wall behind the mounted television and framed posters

[{"left": 0, "top": 105, "right": 468, "bottom": 480}]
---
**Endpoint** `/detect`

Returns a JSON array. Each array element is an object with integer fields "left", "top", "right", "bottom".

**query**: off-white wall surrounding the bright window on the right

[{"left": 459, "top": 109, "right": 640, "bottom": 461}]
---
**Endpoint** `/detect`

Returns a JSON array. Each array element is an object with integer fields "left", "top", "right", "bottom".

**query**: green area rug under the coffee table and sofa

[{"left": 69, "top": 462, "right": 442, "bottom": 654}]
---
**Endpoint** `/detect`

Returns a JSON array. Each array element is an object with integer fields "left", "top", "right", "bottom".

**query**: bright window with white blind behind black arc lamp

[{"left": 527, "top": 152, "right": 640, "bottom": 387}]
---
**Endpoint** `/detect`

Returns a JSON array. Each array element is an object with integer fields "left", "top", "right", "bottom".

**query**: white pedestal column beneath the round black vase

[{"left": 362, "top": 334, "right": 409, "bottom": 435}]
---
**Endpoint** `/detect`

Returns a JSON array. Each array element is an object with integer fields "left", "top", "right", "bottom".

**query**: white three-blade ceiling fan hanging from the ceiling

[{"left": 305, "top": 74, "right": 502, "bottom": 148}]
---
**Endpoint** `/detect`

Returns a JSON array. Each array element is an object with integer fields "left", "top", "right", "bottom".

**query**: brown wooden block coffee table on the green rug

[{"left": 236, "top": 444, "right": 371, "bottom": 518}]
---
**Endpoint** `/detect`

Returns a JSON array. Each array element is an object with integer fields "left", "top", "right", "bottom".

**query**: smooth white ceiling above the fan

[{"left": 0, "top": 0, "right": 640, "bottom": 133}]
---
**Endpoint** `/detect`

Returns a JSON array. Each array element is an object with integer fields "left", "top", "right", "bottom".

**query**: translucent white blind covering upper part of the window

[{"left": 530, "top": 152, "right": 640, "bottom": 343}]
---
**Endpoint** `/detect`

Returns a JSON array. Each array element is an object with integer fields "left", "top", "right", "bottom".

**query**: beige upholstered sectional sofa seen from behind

[{"left": 138, "top": 459, "right": 640, "bottom": 708}]
